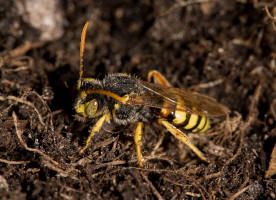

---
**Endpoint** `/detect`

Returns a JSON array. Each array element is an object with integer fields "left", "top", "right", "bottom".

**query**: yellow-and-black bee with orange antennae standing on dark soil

[{"left": 75, "top": 22, "right": 229, "bottom": 167}]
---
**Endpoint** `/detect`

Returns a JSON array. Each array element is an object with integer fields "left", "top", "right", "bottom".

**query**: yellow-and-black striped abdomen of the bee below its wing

[{"left": 172, "top": 111, "right": 209, "bottom": 132}]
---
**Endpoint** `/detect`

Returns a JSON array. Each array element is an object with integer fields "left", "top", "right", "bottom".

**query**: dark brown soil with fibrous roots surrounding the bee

[{"left": 0, "top": 0, "right": 276, "bottom": 199}]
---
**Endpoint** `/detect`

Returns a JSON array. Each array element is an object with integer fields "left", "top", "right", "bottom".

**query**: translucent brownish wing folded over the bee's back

[{"left": 128, "top": 80, "right": 229, "bottom": 117}]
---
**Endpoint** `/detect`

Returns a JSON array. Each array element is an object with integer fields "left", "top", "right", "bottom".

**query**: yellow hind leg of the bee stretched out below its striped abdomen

[{"left": 158, "top": 119, "right": 210, "bottom": 163}]
